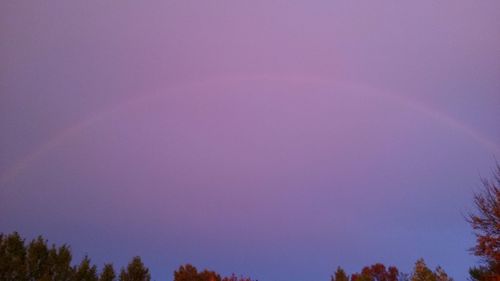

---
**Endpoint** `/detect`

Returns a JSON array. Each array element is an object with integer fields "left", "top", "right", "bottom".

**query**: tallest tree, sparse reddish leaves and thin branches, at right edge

[{"left": 467, "top": 163, "right": 500, "bottom": 280}]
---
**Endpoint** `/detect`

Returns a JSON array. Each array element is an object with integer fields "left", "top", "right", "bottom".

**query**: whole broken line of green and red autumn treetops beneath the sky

[{"left": 0, "top": 164, "right": 500, "bottom": 281}]
